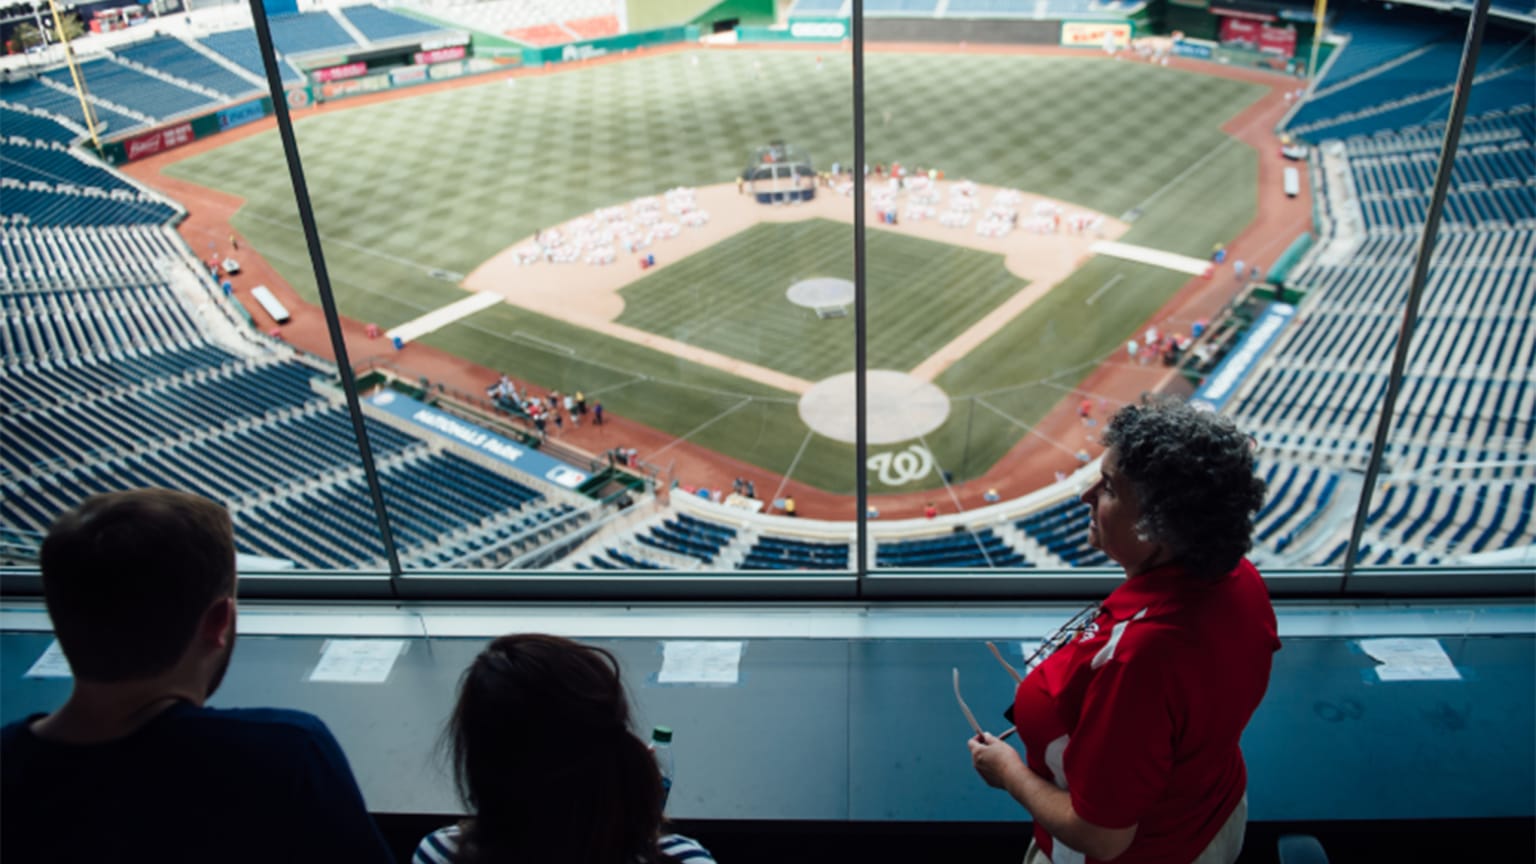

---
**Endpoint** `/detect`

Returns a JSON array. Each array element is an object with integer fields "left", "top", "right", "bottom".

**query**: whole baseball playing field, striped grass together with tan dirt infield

[{"left": 163, "top": 46, "right": 1273, "bottom": 495}]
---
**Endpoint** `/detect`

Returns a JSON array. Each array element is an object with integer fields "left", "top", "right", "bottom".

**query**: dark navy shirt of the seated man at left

[{"left": 0, "top": 703, "right": 392, "bottom": 864}]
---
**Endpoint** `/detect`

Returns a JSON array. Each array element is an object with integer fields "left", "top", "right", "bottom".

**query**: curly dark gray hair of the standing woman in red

[{"left": 1103, "top": 397, "right": 1264, "bottom": 578}]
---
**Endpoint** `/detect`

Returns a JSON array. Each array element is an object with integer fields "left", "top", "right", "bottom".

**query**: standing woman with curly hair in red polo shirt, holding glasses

[{"left": 971, "top": 401, "right": 1279, "bottom": 864}]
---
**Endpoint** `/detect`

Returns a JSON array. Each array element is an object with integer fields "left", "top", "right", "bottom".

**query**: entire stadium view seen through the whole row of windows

[{"left": 0, "top": 0, "right": 1536, "bottom": 595}]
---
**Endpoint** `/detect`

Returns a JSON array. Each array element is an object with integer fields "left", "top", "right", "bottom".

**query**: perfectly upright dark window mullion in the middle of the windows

[{"left": 851, "top": 0, "right": 869, "bottom": 584}]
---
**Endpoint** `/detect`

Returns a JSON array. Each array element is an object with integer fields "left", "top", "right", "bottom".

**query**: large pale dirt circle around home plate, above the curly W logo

[{"left": 800, "top": 369, "right": 949, "bottom": 444}]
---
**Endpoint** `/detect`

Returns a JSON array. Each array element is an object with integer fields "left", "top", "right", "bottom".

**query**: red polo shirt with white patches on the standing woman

[{"left": 1014, "top": 560, "right": 1279, "bottom": 864}]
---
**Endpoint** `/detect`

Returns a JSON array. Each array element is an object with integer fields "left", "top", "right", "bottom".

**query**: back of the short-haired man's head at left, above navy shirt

[{"left": 41, "top": 489, "right": 235, "bottom": 681}]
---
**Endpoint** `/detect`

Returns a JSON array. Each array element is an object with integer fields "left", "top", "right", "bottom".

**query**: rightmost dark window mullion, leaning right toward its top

[{"left": 1339, "top": 0, "right": 1490, "bottom": 592}]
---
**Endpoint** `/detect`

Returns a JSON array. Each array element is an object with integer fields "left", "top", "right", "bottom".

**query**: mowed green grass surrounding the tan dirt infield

[{"left": 167, "top": 51, "right": 1263, "bottom": 492}]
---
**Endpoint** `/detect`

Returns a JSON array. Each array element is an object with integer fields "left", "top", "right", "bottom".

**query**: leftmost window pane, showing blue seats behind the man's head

[{"left": 0, "top": 15, "right": 404, "bottom": 572}]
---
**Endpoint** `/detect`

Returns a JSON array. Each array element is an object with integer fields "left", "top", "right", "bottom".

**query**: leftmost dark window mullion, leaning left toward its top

[{"left": 250, "top": 0, "right": 401, "bottom": 598}]
